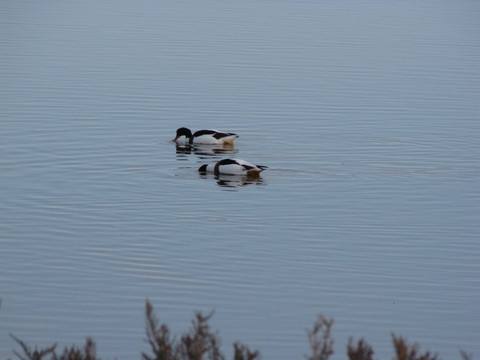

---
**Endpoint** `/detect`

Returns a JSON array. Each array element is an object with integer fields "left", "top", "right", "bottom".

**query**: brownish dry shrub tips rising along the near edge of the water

[{"left": 6, "top": 300, "right": 472, "bottom": 360}]
